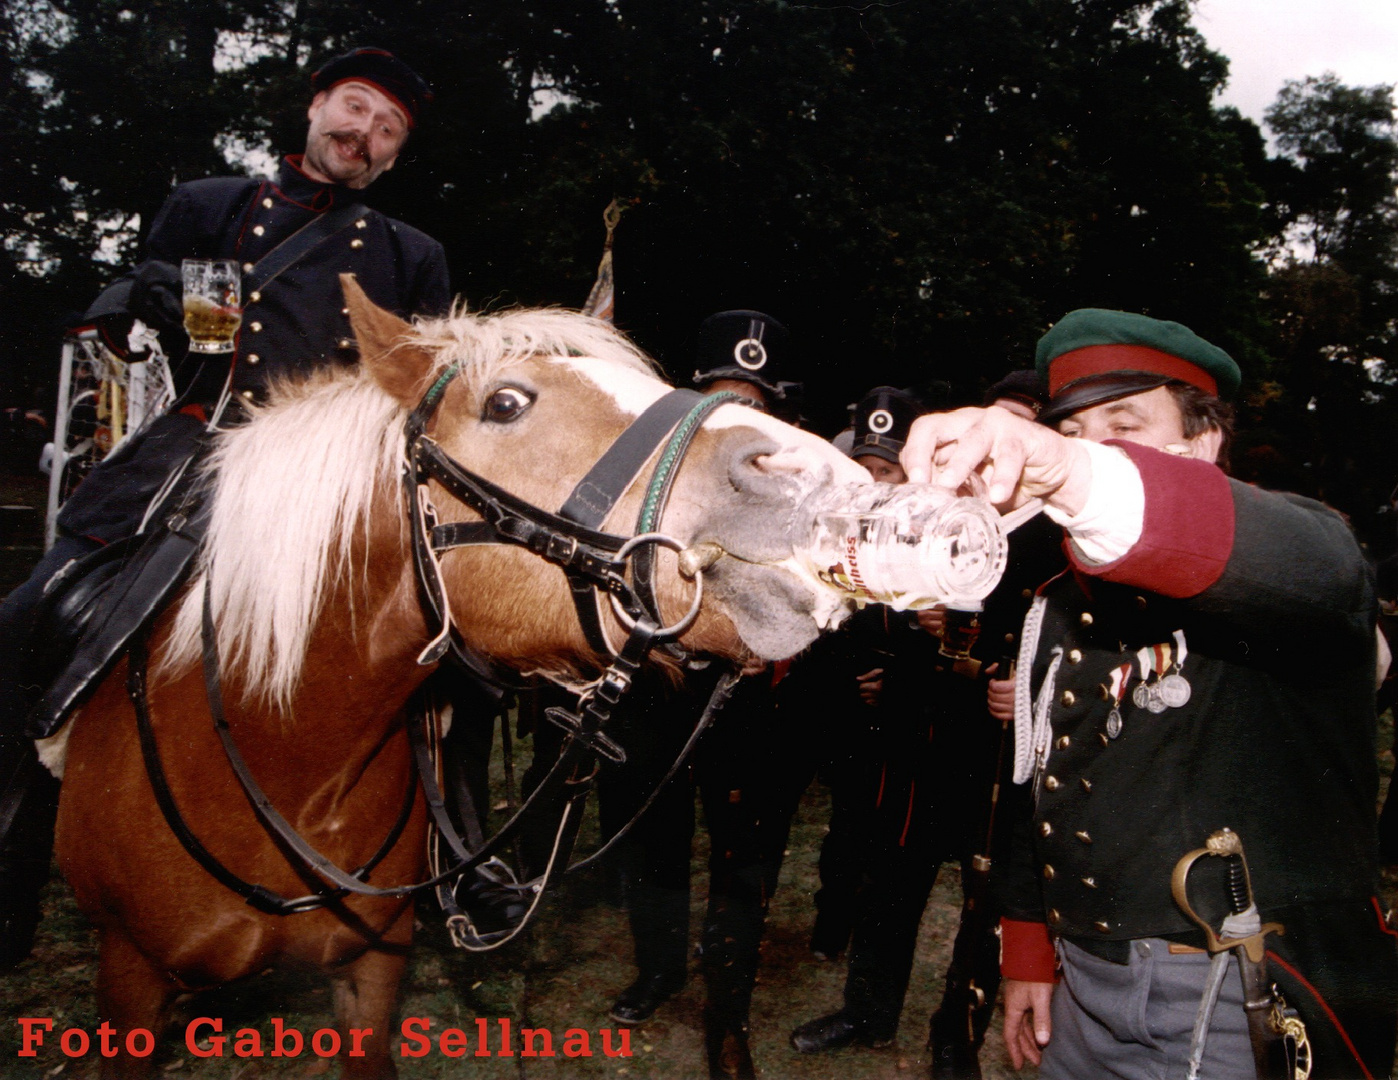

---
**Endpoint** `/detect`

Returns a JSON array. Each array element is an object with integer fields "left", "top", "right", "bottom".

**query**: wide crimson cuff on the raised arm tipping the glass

[{"left": 1068, "top": 440, "right": 1234, "bottom": 598}]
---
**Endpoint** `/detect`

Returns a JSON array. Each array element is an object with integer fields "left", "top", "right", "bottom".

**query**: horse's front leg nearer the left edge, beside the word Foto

[{"left": 96, "top": 929, "right": 179, "bottom": 1080}]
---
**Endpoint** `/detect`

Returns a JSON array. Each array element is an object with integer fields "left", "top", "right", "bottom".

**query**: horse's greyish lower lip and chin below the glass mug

[{"left": 706, "top": 559, "right": 854, "bottom": 659}]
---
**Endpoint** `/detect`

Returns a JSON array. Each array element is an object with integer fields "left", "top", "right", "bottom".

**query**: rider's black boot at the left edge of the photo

[{"left": 0, "top": 738, "right": 59, "bottom": 971}]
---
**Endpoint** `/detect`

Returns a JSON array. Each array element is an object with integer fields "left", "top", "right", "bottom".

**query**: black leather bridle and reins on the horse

[{"left": 127, "top": 365, "right": 738, "bottom": 927}]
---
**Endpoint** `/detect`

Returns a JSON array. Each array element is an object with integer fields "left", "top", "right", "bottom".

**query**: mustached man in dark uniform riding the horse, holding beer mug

[{"left": 0, "top": 49, "right": 452, "bottom": 970}]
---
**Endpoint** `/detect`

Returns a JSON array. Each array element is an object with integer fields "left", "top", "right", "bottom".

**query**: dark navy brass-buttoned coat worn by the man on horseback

[{"left": 59, "top": 156, "right": 452, "bottom": 541}]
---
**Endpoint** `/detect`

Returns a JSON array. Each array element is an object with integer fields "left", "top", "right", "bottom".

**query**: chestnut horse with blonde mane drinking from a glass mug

[{"left": 49, "top": 279, "right": 863, "bottom": 1077}]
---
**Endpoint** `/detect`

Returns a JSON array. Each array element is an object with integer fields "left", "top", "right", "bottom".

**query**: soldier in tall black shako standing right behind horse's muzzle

[{"left": 601, "top": 310, "right": 815, "bottom": 1077}]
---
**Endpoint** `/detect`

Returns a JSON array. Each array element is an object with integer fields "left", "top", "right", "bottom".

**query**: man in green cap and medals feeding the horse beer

[{"left": 903, "top": 309, "right": 1398, "bottom": 1080}]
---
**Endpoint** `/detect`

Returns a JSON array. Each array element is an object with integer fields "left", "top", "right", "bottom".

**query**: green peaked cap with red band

[{"left": 1035, "top": 307, "right": 1243, "bottom": 421}]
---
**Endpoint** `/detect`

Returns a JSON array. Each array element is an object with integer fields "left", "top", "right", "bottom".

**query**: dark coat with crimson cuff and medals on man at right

[{"left": 997, "top": 444, "right": 1398, "bottom": 1074}]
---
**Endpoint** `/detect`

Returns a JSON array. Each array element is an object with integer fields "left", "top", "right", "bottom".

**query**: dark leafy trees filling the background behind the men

[{"left": 0, "top": 0, "right": 1398, "bottom": 547}]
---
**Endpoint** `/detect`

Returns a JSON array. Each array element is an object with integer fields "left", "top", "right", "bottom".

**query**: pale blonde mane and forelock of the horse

[{"left": 159, "top": 309, "right": 654, "bottom": 713}]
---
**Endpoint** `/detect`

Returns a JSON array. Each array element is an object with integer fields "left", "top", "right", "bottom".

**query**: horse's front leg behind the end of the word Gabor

[{"left": 331, "top": 905, "right": 412, "bottom": 1080}]
